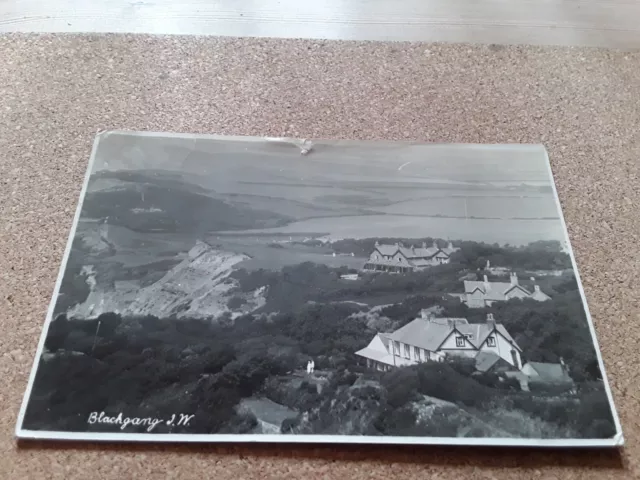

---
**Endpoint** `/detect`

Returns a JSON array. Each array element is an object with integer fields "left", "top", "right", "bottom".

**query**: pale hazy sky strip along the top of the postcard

[{"left": 93, "top": 133, "right": 552, "bottom": 185}]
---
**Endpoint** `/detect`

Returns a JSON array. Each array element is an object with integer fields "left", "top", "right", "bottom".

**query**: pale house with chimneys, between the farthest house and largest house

[{"left": 458, "top": 273, "right": 551, "bottom": 308}]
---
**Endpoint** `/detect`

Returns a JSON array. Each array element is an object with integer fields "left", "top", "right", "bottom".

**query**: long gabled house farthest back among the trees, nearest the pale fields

[{"left": 364, "top": 242, "right": 460, "bottom": 273}]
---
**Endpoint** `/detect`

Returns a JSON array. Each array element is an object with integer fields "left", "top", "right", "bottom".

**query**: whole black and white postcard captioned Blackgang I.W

[{"left": 16, "top": 132, "right": 623, "bottom": 446}]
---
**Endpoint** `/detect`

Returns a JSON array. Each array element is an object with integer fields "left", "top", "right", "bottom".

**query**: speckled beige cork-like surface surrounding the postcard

[{"left": 0, "top": 36, "right": 640, "bottom": 480}]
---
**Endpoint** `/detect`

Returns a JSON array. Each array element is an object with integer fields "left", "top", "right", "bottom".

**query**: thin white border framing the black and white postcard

[{"left": 15, "top": 130, "right": 624, "bottom": 448}]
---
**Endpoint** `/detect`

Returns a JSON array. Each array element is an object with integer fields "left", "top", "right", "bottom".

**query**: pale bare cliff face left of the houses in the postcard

[{"left": 67, "top": 242, "right": 265, "bottom": 318}]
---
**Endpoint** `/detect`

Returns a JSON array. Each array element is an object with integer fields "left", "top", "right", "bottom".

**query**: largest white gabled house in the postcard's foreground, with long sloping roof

[{"left": 356, "top": 312, "right": 522, "bottom": 371}]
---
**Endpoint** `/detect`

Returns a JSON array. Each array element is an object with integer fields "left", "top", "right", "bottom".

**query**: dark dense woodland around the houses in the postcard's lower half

[{"left": 25, "top": 241, "right": 615, "bottom": 437}]
